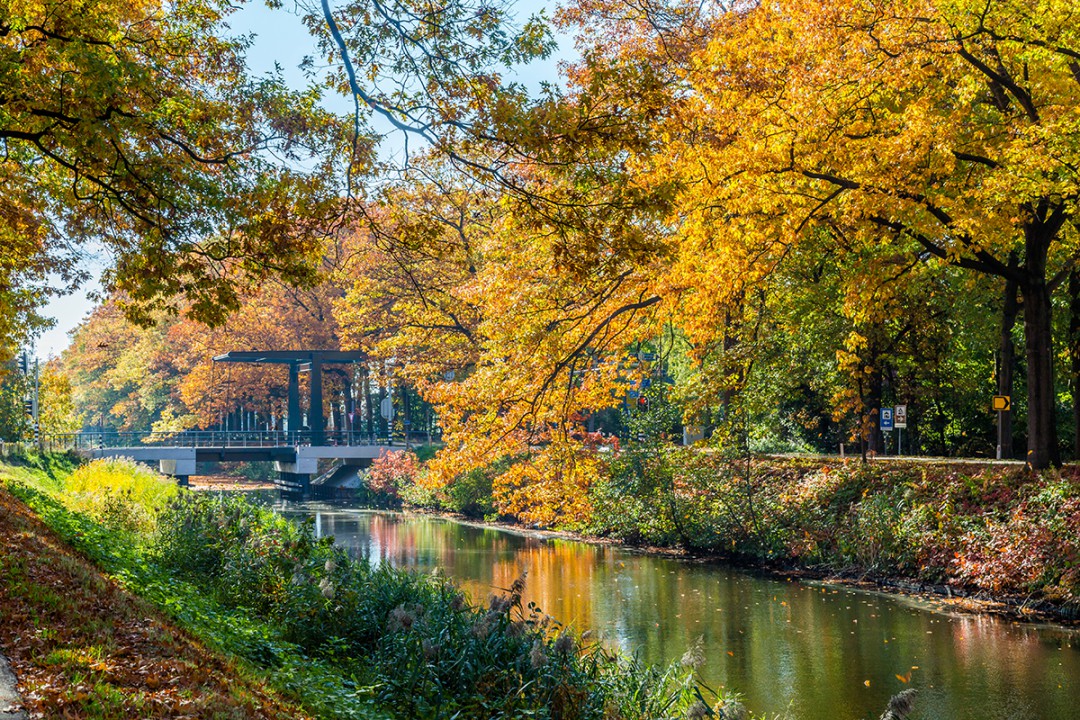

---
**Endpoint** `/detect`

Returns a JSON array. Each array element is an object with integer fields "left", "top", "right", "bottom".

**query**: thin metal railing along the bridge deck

[{"left": 43, "top": 430, "right": 402, "bottom": 450}]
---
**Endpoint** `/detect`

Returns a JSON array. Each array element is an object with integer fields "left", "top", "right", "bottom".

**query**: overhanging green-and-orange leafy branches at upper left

[{"left": 0, "top": 0, "right": 369, "bottom": 351}]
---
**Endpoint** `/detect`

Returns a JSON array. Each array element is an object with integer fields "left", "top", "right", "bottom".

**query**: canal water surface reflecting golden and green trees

[{"left": 289, "top": 505, "right": 1080, "bottom": 720}]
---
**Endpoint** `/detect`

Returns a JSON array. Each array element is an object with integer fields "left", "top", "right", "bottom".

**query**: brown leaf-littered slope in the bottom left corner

[{"left": 0, "top": 488, "right": 308, "bottom": 719}]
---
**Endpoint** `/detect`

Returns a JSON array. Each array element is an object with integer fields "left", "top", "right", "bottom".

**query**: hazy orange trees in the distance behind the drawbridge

[{"left": 63, "top": 269, "right": 339, "bottom": 432}]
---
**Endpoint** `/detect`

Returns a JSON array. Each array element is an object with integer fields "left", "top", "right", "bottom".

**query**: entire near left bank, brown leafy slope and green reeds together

[{"left": 0, "top": 458, "right": 745, "bottom": 720}]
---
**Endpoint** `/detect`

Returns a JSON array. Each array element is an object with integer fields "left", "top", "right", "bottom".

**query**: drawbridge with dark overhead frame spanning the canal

[{"left": 50, "top": 350, "right": 412, "bottom": 494}]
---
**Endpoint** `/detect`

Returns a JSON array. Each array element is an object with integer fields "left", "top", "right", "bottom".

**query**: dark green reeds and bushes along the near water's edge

[{"left": 156, "top": 493, "right": 721, "bottom": 720}]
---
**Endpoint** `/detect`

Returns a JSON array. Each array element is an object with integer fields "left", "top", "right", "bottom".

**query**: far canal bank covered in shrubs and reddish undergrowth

[{"left": 368, "top": 444, "right": 1080, "bottom": 615}]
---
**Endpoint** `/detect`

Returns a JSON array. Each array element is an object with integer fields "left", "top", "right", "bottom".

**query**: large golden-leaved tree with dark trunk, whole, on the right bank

[{"left": 630, "top": 0, "right": 1080, "bottom": 467}]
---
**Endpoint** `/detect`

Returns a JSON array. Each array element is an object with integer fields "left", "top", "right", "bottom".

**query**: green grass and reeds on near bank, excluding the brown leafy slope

[{"left": 0, "top": 455, "right": 743, "bottom": 720}]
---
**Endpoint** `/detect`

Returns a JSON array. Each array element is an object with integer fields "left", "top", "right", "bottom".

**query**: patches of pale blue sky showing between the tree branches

[{"left": 36, "top": 0, "right": 571, "bottom": 359}]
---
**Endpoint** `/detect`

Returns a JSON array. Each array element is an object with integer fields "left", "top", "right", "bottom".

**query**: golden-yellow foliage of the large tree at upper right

[{"left": 643, "top": 0, "right": 1078, "bottom": 278}]
